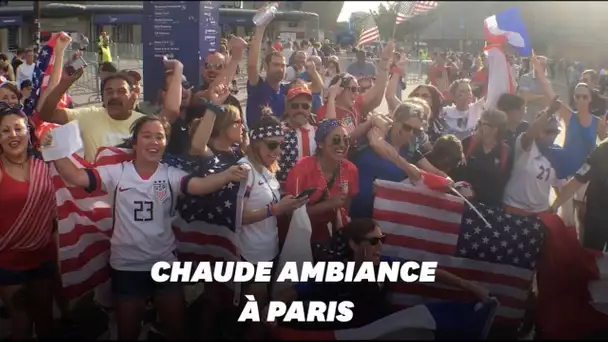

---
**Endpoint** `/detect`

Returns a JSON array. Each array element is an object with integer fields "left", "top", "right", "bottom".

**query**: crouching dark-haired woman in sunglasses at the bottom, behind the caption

[{"left": 276, "top": 218, "right": 490, "bottom": 337}]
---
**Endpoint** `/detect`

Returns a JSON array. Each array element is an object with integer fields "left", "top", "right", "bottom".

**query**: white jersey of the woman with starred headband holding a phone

[{"left": 236, "top": 157, "right": 281, "bottom": 263}]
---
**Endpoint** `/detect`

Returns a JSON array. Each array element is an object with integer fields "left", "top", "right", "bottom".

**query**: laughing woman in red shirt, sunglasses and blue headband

[{"left": 285, "top": 119, "right": 359, "bottom": 243}]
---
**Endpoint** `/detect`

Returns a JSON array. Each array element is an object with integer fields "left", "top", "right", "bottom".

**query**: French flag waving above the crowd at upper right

[{"left": 484, "top": 7, "right": 532, "bottom": 56}]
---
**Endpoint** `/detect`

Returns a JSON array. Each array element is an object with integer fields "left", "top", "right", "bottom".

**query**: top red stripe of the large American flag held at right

[{"left": 375, "top": 186, "right": 465, "bottom": 214}]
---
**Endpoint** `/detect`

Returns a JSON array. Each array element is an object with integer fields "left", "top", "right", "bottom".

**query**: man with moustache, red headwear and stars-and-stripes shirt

[{"left": 277, "top": 85, "right": 317, "bottom": 182}]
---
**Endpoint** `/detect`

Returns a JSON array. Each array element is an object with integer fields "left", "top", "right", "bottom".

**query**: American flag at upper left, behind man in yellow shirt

[{"left": 24, "top": 33, "right": 70, "bottom": 126}]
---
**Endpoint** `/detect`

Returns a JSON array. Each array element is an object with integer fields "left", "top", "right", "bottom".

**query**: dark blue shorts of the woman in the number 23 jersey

[{"left": 110, "top": 269, "right": 182, "bottom": 299}]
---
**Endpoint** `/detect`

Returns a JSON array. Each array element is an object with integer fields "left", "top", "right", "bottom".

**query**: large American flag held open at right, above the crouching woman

[{"left": 373, "top": 180, "right": 544, "bottom": 326}]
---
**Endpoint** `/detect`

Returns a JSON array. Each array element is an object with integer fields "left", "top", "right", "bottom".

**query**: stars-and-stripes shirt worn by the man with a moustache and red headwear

[{"left": 277, "top": 125, "right": 317, "bottom": 182}]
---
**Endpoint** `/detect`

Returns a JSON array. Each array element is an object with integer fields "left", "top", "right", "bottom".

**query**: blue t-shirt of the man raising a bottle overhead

[{"left": 246, "top": 77, "right": 287, "bottom": 127}]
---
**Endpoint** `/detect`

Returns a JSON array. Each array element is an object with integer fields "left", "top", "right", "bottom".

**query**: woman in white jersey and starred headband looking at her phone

[{"left": 236, "top": 115, "right": 308, "bottom": 339}]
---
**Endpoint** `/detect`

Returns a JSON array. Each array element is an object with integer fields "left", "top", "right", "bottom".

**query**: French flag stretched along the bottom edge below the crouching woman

[{"left": 272, "top": 299, "right": 498, "bottom": 341}]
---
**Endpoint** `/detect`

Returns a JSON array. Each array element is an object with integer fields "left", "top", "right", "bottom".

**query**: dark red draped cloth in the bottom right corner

[{"left": 536, "top": 214, "right": 608, "bottom": 339}]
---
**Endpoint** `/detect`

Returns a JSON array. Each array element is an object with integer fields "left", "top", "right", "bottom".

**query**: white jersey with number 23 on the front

[{"left": 96, "top": 162, "right": 186, "bottom": 272}]
